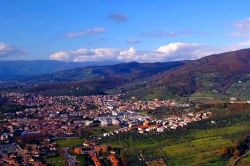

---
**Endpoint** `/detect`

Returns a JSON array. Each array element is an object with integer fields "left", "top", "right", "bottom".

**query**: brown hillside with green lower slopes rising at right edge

[{"left": 125, "top": 49, "right": 250, "bottom": 99}]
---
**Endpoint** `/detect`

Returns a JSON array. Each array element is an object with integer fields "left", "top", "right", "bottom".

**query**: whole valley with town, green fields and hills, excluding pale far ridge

[{"left": 0, "top": 49, "right": 250, "bottom": 166}]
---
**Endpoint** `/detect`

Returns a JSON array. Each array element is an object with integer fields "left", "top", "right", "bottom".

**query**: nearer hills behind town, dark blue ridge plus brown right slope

[{"left": 1, "top": 49, "right": 250, "bottom": 99}]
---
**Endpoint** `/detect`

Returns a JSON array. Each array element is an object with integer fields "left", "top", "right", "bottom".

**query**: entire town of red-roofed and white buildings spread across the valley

[{"left": 0, "top": 93, "right": 212, "bottom": 165}]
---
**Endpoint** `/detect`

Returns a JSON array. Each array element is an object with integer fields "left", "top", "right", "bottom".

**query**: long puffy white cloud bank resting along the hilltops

[{"left": 50, "top": 41, "right": 250, "bottom": 62}]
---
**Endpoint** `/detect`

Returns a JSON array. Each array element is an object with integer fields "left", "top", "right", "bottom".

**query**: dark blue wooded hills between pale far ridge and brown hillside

[{"left": 2, "top": 61, "right": 186, "bottom": 95}]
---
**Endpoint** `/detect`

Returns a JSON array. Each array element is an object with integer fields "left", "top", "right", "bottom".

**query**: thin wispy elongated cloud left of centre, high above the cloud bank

[{"left": 66, "top": 27, "right": 106, "bottom": 38}]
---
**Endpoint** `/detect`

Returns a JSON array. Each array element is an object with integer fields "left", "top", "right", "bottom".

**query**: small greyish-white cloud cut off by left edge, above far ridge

[{"left": 0, "top": 42, "right": 24, "bottom": 59}]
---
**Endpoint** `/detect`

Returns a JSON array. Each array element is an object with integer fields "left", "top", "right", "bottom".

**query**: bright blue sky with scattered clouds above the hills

[{"left": 0, "top": 0, "right": 250, "bottom": 62}]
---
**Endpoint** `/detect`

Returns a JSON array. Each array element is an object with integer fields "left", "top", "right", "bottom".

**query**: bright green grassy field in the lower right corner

[{"left": 163, "top": 123, "right": 250, "bottom": 165}]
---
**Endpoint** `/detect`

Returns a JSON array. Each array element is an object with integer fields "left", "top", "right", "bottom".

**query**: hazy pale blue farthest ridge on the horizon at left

[{"left": 0, "top": 60, "right": 117, "bottom": 81}]
